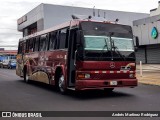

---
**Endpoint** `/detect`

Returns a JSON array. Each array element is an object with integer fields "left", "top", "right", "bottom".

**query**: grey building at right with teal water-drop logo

[{"left": 133, "top": 1, "right": 160, "bottom": 64}]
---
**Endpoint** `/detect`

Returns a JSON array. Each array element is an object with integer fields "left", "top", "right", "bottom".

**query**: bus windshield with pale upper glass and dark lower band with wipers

[{"left": 80, "top": 31, "right": 135, "bottom": 61}]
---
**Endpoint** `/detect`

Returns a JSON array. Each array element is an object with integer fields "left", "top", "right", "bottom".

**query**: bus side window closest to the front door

[{"left": 58, "top": 28, "right": 67, "bottom": 49}]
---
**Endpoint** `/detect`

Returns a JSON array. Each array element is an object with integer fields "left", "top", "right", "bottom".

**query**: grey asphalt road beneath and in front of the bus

[{"left": 0, "top": 69, "right": 160, "bottom": 120}]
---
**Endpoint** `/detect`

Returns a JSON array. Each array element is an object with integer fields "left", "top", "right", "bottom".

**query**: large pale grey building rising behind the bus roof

[{"left": 17, "top": 4, "right": 149, "bottom": 36}]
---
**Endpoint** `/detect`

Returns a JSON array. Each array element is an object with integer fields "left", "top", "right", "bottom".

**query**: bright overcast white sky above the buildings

[{"left": 0, "top": 0, "right": 159, "bottom": 50}]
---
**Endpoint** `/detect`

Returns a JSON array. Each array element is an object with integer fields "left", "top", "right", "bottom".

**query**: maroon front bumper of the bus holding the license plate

[{"left": 75, "top": 79, "right": 138, "bottom": 90}]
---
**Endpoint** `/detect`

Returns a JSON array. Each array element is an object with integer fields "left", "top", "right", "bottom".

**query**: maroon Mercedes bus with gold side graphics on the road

[{"left": 16, "top": 19, "right": 138, "bottom": 93}]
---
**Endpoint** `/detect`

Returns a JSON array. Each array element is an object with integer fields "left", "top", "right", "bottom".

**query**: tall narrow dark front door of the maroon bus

[{"left": 67, "top": 29, "right": 77, "bottom": 87}]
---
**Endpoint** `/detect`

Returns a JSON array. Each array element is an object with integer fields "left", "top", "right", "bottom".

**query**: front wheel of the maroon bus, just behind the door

[{"left": 58, "top": 74, "right": 67, "bottom": 94}]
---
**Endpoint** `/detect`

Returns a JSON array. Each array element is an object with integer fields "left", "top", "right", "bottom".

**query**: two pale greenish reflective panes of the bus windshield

[{"left": 84, "top": 35, "right": 134, "bottom": 51}]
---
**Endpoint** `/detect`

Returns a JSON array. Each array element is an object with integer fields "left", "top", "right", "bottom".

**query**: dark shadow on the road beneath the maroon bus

[{"left": 18, "top": 80, "right": 134, "bottom": 100}]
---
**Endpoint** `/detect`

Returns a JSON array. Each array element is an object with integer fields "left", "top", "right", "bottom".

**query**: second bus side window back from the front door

[{"left": 49, "top": 31, "right": 57, "bottom": 50}]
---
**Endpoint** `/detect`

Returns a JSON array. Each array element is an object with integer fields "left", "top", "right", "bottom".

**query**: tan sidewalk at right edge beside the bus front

[{"left": 136, "top": 64, "right": 160, "bottom": 86}]
